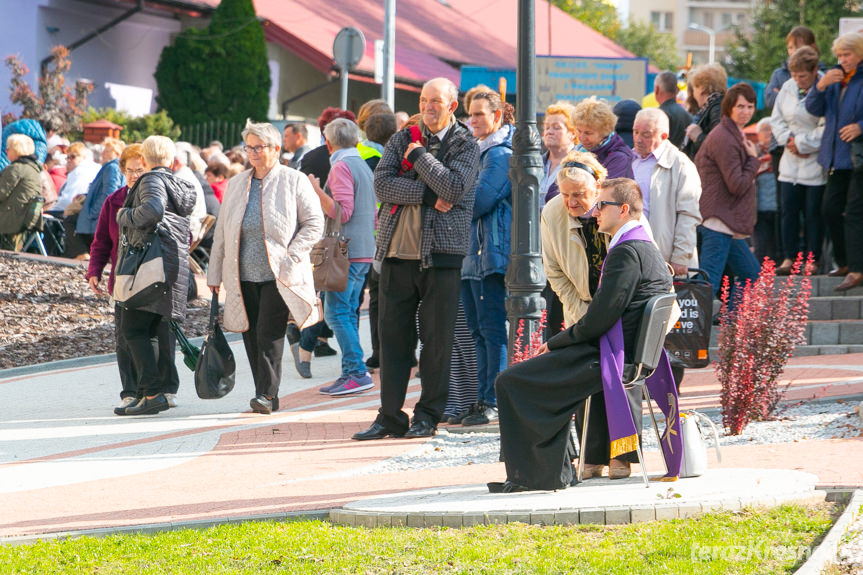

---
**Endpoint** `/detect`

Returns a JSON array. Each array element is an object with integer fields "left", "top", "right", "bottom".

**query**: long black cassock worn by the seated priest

[{"left": 495, "top": 241, "right": 672, "bottom": 489}]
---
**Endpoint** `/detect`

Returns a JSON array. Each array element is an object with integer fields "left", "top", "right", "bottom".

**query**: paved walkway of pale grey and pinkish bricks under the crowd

[{"left": 0, "top": 312, "right": 863, "bottom": 537}]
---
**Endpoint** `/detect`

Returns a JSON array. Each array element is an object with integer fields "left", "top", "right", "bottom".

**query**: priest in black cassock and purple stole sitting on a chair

[{"left": 488, "top": 178, "right": 680, "bottom": 493}]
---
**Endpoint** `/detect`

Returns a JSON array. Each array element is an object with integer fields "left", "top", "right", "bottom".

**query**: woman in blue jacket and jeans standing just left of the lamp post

[{"left": 461, "top": 91, "right": 515, "bottom": 425}]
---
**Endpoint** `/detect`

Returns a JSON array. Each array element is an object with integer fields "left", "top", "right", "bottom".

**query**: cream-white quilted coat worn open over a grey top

[{"left": 207, "top": 164, "right": 324, "bottom": 332}]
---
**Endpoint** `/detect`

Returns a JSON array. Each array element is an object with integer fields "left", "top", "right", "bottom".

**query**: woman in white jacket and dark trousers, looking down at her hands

[{"left": 770, "top": 46, "right": 827, "bottom": 275}]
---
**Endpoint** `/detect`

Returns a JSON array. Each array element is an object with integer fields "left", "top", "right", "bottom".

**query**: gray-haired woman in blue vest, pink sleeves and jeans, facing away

[{"left": 308, "top": 118, "right": 375, "bottom": 395}]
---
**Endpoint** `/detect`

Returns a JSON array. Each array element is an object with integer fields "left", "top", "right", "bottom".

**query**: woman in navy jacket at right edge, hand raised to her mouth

[{"left": 806, "top": 33, "right": 863, "bottom": 291}]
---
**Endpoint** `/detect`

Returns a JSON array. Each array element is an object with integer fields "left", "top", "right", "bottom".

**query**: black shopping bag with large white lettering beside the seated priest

[{"left": 665, "top": 269, "right": 713, "bottom": 368}]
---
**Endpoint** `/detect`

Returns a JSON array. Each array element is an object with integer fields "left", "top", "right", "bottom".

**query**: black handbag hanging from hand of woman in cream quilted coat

[{"left": 195, "top": 294, "right": 237, "bottom": 399}]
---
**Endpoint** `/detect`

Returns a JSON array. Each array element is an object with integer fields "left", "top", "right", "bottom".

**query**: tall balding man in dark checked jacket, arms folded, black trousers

[{"left": 353, "top": 78, "right": 480, "bottom": 440}]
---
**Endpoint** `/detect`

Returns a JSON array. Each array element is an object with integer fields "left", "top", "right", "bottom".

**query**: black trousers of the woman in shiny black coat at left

[{"left": 116, "top": 308, "right": 180, "bottom": 397}]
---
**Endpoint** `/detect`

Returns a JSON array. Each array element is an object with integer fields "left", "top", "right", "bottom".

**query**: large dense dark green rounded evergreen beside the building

[{"left": 155, "top": 0, "right": 270, "bottom": 125}]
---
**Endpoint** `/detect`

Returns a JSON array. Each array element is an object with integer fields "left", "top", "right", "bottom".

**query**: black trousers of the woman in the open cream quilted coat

[{"left": 240, "top": 281, "right": 290, "bottom": 406}]
